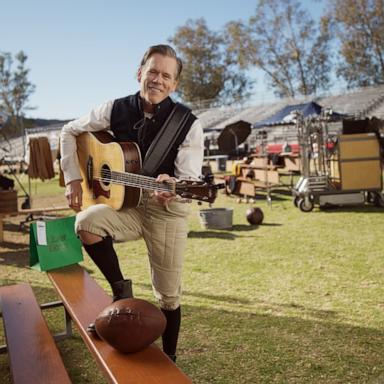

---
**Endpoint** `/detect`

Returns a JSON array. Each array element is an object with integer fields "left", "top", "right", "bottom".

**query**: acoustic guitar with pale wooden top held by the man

[{"left": 76, "top": 131, "right": 221, "bottom": 210}]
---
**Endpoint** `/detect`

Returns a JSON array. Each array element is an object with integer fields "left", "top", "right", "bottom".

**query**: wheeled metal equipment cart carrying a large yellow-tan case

[{"left": 292, "top": 111, "right": 384, "bottom": 212}]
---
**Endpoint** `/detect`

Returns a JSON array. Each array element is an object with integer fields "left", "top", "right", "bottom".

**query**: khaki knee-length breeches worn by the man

[{"left": 75, "top": 198, "right": 190, "bottom": 310}]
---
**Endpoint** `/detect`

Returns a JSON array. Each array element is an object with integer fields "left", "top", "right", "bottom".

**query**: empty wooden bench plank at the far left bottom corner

[{"left": 0, "top": 284, "right": 71, "bottom": 384}]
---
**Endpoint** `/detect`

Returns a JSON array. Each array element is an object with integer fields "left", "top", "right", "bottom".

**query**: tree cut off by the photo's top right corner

[{"left": 327, "top": 0, "right": 384, "bottom": 88}]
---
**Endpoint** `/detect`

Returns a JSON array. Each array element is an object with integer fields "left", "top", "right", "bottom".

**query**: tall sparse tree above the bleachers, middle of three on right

[{"left": 227, "top": 0, "right": 331, "bottom": 97}]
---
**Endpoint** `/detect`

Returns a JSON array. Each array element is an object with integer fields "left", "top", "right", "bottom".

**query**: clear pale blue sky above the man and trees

[{"left": 0, "top": 0, "right": 321, "bottom": 119}]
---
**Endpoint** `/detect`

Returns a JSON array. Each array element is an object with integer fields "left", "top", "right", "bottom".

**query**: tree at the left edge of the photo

[{"left": 0, "top": 51, "right": 35, "bottom": 135}]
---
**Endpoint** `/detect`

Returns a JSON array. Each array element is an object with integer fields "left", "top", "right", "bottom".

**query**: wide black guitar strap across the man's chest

[{"left": 140, "top": 103, "right": 191, "bottom": 176}]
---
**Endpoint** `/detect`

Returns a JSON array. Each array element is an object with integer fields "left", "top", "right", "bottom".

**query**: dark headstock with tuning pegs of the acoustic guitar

[{"left": 175, "top": 180, "right": 224, "bottom": 203}]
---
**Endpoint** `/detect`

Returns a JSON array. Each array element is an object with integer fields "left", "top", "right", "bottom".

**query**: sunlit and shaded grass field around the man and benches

[{"left": 0, "top": 185, "right": 384, "bottom": 384}]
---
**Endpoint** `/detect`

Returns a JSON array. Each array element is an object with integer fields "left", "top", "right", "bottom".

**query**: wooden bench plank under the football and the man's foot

[{"left": 48, "top": 264, "right": 192, "bottom": 384}]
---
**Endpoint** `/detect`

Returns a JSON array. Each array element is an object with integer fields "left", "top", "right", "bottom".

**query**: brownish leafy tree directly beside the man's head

[{"left": 169, "top": 18, "right": 252, "bottom": 107}]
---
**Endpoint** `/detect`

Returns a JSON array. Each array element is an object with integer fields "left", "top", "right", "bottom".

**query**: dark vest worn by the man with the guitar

[{"left": 111, "top": 93, "right": 196, "bottom": 177}]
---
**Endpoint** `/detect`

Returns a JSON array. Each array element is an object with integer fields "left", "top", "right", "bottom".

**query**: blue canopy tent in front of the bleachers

[{"left": 252, "top": 101, "right": 343, "bottom": 128}]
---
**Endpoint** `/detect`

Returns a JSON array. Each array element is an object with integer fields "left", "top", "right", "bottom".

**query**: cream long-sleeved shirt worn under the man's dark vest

[{"left": 60, "top": 100, "right": 204, "bottom": 184}]
